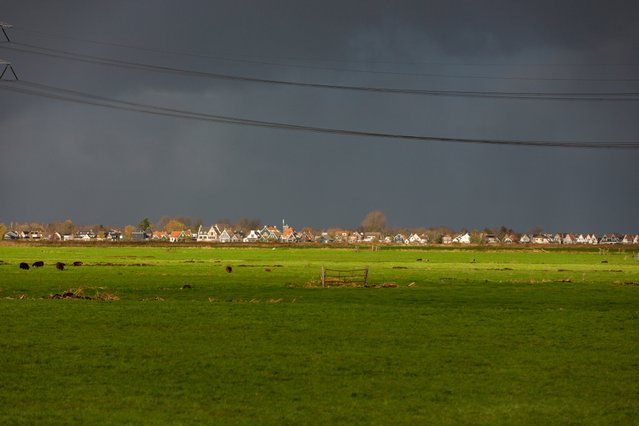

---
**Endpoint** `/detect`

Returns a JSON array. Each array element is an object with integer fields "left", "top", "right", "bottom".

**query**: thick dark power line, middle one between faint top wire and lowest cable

[{"left": 0, "top": 43, "right": 639, "bottom": 102}]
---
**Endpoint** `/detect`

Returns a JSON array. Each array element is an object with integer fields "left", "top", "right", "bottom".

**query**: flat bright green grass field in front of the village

[{"left": 0, "top": 244, "right": 639, "bottom": 425}]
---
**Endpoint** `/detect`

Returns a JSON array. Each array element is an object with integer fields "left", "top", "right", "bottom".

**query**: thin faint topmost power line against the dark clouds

[{"left": 8, "top": 27, "right": 639, "bottom": 83}]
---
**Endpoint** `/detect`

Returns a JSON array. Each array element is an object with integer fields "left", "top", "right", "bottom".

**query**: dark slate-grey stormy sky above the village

[{"left": 0, "top": 0, "right": 639, "bottom": 233}]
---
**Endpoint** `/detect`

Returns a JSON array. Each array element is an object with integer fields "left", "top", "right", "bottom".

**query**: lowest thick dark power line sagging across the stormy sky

[{"left": 0, "top": 81, "right": 639, "bottom": 149}]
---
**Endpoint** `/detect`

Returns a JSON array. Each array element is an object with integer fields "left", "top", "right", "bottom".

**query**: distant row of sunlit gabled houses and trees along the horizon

[{"left": 0, "top": 210, "right": 639, "bottom": 245}]
